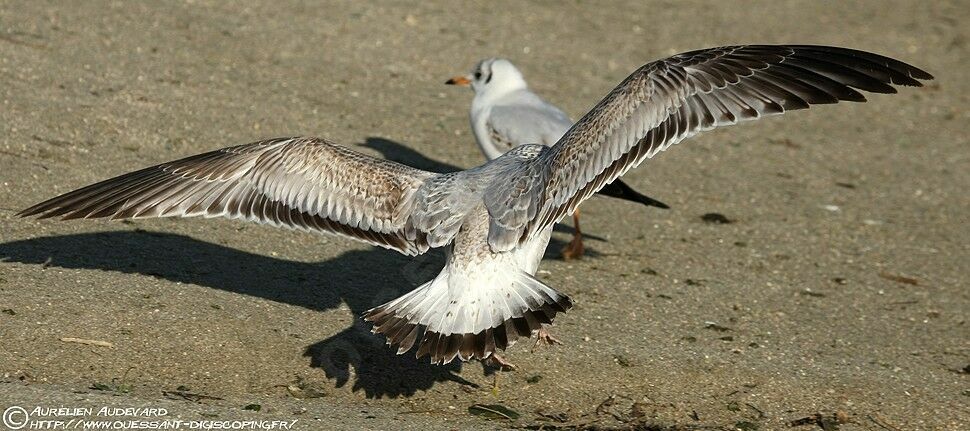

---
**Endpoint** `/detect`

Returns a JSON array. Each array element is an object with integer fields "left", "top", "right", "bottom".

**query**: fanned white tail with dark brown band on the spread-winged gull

[{"left": 364, "top": 271, "right": 572, "bottom": 364}]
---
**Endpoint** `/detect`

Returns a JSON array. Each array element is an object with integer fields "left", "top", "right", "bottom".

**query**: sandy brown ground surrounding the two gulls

[{"left": 0, "top": 1, "right": 970, "bottom": 430}]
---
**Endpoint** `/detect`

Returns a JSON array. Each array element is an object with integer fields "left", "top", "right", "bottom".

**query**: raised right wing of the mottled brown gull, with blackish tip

[{"left": 490, "top": 45, "right": 933, "bottom": 250}]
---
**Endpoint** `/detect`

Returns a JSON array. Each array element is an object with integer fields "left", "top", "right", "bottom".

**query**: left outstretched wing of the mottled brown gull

[{"left": 19, "top": 138, "right": 436, "bottom": 255}]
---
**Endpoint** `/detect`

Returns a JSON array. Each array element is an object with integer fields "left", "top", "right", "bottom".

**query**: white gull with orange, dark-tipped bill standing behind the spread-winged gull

[{"left": 445, "top": 58, "right": 669, "bottom": 259}]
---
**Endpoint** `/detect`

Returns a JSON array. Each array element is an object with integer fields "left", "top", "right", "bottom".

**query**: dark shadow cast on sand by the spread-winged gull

[{"left": 0, "top": 229, "right": 478, "bottom": 398}]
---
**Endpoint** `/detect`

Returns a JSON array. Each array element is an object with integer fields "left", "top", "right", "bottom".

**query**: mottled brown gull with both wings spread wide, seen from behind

[{"left": 20, "top": 46, "right": 932, "bottom": 364}]
